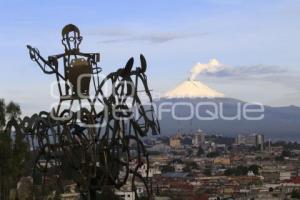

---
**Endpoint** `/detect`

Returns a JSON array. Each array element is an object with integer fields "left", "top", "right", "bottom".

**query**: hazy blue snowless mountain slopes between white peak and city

[{"left": 155, "top": 97, "right": 300, "bottom": 140}]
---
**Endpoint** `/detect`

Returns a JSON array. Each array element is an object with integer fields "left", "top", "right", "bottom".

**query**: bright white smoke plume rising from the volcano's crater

[{"left": 189, "top": 59, "right": 223, "bottom": 81}]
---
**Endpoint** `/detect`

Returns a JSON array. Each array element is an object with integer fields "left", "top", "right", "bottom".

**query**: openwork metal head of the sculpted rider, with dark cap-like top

[{"left": 61, "top": 24, "right": 82, "bottom": 52}]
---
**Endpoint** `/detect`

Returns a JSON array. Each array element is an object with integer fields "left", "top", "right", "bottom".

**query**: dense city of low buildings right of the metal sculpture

[{"left": 145, "top": 130, "right": 300, "bottom": 199}]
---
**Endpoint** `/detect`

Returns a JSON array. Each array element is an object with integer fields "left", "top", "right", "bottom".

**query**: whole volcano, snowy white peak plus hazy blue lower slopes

[{"left": 155, "top": 79, "right": 300, "bottom": 140}]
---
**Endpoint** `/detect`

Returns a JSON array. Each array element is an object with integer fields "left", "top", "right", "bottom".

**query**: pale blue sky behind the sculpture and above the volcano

[{"left": 0, "top": 0, "right": 300, "bottom": 114}]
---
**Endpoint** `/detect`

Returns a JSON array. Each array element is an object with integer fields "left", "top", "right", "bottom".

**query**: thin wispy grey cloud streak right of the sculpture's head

[{"left": 91, "top": 28, "right": 209, "bottom": 43}]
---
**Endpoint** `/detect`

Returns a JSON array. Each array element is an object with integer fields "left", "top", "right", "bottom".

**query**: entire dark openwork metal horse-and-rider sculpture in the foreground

[{"left": 7, "top": 24, "right": 159, "bottom": 199}]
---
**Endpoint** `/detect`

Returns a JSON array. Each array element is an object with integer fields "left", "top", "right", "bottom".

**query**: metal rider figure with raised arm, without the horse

[{"left": 27, "top": 24, "right": 101, "bottom": 116}]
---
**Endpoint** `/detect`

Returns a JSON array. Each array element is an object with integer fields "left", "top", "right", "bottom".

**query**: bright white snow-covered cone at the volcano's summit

[{"left": 164, "top": 80, "right": 224, "bottom": 98}]
